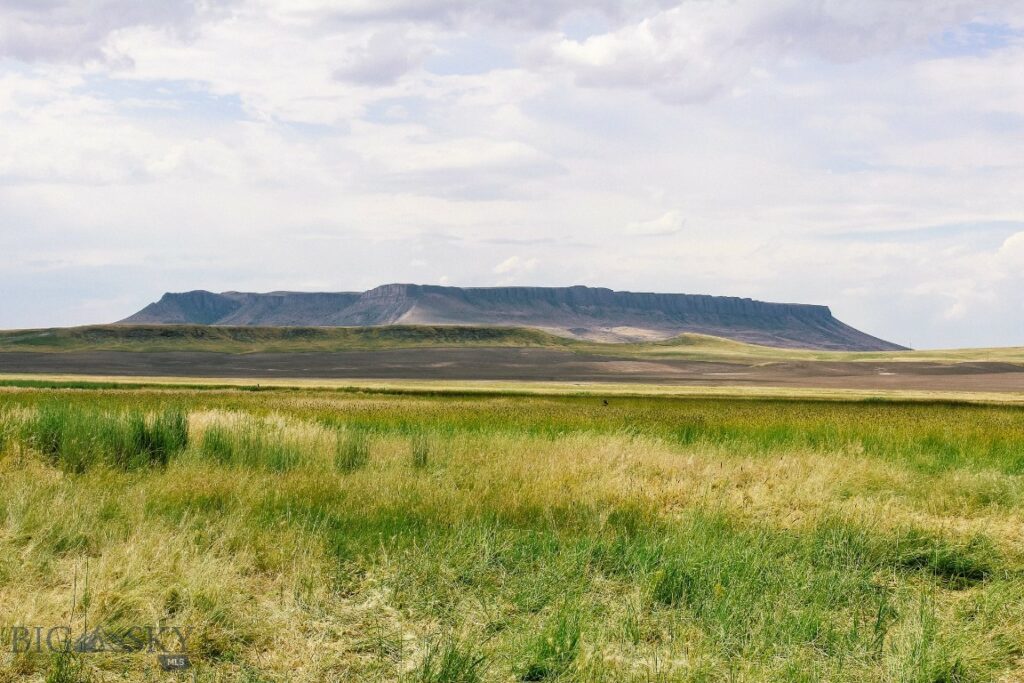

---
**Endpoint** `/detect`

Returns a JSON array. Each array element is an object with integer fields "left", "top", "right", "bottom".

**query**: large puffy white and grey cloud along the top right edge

[{"left": 535, "top": 0, "right": 1024, "bottom": 103}]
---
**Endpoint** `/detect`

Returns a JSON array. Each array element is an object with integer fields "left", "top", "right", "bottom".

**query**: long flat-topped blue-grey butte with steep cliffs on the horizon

[{"left": 121, "top": 285, "right": 902, "bottom": 351}]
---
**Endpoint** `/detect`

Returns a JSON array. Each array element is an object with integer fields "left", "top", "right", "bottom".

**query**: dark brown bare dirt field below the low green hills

[{"left": 0, "top": 348, "right": 1024, "bottom": 392}]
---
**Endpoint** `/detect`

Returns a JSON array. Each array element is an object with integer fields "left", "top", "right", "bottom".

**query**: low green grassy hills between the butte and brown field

[{"left": 0, "top": 325, "right": 1024, "bottom": 366}]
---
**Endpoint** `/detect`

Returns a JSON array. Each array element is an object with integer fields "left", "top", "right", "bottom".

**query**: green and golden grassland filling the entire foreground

[{"left": 0, "top": 388, "right": 1024, "bottom": 683}]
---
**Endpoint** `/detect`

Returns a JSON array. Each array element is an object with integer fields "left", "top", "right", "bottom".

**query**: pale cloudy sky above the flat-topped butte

[{"left": 0, "top": 0, "right": 1024, "bottom": 348}]
